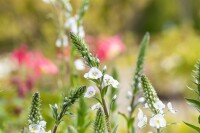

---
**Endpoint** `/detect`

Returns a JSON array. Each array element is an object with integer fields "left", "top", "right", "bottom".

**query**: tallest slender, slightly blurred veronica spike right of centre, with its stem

[{"left": 119, "top": 33, "right": 150, "bottom": 133}]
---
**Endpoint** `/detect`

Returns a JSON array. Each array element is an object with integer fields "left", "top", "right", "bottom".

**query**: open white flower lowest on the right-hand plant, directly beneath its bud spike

[{"left": 149, "top": 114, "right": 166, "bottom": 128}]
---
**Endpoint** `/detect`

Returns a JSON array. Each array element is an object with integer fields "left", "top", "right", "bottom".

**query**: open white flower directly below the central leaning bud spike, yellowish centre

[{"left": 84, "top": 67, "right": 102, "bottom": 79}]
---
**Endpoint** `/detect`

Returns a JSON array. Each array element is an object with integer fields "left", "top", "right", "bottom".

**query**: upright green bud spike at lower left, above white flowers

[{"left": 28, "top": 92, "right": 42, "bottom": 124}]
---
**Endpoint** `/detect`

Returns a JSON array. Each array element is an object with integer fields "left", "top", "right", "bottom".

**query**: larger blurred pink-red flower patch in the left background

[{"left": 11, "top": 45, "right": 58, "bottom": 76}]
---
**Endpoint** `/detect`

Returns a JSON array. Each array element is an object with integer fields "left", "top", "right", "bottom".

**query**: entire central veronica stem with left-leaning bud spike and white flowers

[{"left": 70, "top": 33, "right": 119, "bottom": 133}]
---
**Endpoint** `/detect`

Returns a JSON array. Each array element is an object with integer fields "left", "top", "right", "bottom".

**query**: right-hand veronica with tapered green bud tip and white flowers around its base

[{"left": 137, "top": 75, "right": 176, "bottom": 133}]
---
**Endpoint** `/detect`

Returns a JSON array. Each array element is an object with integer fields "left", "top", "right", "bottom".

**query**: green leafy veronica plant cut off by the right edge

[{"left": 185, "top": 60, "right": 200, "bottom": 133}]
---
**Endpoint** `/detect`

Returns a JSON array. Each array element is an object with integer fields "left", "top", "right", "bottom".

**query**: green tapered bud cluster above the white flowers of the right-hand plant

[{"left": 141, "top": 75, "right": 159, "bottom": 114}]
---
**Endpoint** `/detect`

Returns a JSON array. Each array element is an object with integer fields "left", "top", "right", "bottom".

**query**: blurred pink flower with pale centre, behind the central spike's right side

[{"left": 96, "top": 36, "right": 126, "bottom": 60}]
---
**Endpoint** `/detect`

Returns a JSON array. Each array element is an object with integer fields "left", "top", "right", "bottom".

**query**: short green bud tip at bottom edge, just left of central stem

[{"left": 94, "top": 108, "right": 106, "bottom": 133}]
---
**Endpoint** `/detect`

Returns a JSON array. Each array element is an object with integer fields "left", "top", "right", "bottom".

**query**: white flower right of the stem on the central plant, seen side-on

[{"left": 103, "top": 74, "right": 119, "bottom": 88}]
